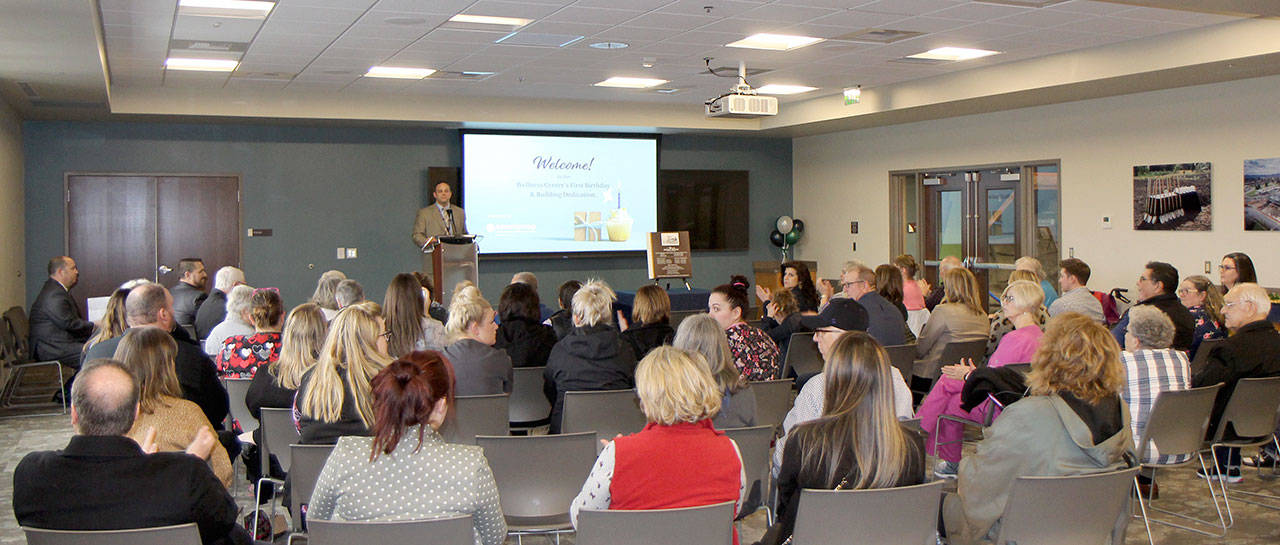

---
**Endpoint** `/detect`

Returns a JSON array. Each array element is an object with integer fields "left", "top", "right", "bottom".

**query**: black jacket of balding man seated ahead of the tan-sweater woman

[{"left": 84, "top": 328, "right": 230, "bottom": 430}]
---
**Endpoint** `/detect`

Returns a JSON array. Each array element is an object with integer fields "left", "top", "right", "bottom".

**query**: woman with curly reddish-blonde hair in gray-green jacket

[{"left": 942, "top": 313, "right": 1133, "bottom": 545}]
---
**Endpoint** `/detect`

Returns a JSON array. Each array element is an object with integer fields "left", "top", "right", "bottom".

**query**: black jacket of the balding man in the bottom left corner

[{"left": 13, "top": 435, "right": 250, "bottom": 545}]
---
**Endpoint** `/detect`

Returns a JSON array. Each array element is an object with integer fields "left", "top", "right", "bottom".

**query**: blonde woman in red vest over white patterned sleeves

[{"left": 570, "top": 347, "right": 746, "bottom": 545}]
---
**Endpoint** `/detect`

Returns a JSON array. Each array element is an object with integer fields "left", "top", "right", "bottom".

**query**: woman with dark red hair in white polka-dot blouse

[{"left": 307, "top": 352, "right": 507, "bottom": 545}]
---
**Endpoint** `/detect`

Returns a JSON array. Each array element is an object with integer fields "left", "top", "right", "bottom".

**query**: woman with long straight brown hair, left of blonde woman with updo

[{"left": 383, "top": 273, "right": 447, "bottom": 358}]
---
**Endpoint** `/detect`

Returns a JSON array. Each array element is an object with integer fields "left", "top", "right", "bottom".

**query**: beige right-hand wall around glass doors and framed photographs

[{"left": 792, "top": 77, "right": 1280, "bottom": 295}]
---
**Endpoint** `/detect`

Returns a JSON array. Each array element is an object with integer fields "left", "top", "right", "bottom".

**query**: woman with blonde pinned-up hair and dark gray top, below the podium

[{"left": 444, "top": 284, "right": 512, "bottom": 395}]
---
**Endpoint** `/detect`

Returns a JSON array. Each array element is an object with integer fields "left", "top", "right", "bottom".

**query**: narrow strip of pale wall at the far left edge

[{"left": 0, "top": 100, "right": 27, "bottom": 310}]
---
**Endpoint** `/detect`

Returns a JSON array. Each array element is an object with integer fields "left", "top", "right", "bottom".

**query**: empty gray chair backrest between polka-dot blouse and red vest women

[{"left": 476, "top": 431, "right": 596, "bottom": 521}]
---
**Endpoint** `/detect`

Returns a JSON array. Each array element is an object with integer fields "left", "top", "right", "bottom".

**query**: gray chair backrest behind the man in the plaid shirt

[{"left": 1138, "top": 384, "right": 1222, "bottom": 461}]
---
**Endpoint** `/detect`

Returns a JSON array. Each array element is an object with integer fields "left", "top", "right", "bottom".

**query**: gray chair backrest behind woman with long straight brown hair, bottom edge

[{"left": 794, "top": 480, "right": 946, "bottom": 545}]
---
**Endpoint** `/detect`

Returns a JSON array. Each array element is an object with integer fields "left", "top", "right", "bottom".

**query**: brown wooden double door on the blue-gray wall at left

[{"left": 67, "top": 173, "right": 241, "bottom": 301}]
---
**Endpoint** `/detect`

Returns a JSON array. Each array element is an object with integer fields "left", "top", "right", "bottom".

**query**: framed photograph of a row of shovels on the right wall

[{"left": 1133, "top": 162, "right": 1213, "bottom": 230}]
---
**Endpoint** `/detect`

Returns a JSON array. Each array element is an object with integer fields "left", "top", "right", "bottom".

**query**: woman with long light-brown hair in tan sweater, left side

[{"left": 113, "top": 328, "right": 233, "bottom": 486}]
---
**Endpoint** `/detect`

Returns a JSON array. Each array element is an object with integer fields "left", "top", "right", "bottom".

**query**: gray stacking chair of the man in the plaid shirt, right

[{"left": 1134, "top": 384, "right": 1228, "bottom": 545}]
